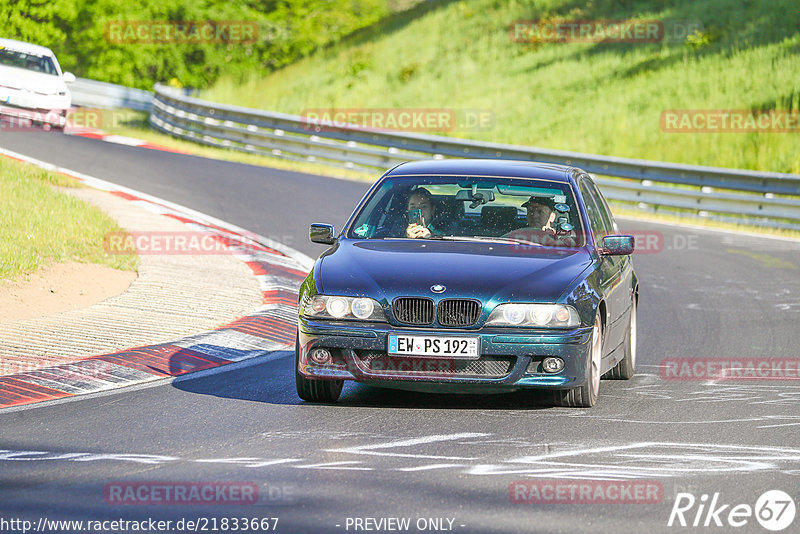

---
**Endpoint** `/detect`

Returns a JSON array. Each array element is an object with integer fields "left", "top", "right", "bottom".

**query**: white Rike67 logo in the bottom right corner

[{"left": 667, "top": 490, "right": 797, "bottom": 532}]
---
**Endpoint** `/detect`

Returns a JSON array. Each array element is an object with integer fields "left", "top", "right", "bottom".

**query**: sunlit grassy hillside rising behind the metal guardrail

[{"left": 203, "top": 0, "right": 800, "bottom": 173}]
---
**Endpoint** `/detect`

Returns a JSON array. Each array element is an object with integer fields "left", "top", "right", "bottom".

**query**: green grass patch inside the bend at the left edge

[{"left": 0, "top": 158, "right": 139, "bottom": 280}]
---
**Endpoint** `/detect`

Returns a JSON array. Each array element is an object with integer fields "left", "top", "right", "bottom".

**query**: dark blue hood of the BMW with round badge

[{"left": 316, "top": 240, "right": 592, "bottom": 303}]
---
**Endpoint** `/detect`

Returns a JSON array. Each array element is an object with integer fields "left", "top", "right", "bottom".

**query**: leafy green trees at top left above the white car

[{"left": 0, "top": 0, "right": 389, "bottom": 89}]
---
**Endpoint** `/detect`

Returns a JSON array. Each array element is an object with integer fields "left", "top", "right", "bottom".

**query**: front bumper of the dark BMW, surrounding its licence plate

[{"left": 297, "top": 317, "right": 592, "bottom": 392}]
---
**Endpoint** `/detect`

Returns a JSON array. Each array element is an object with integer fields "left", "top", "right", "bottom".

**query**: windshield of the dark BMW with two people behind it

[{"left": 348, "top": 176, "right": 585, "bottom": 247}]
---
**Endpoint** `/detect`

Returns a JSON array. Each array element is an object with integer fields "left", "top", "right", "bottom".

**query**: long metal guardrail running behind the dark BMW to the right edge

[{"left": 150, "top": 85, "right": 800, "bottom": 229}]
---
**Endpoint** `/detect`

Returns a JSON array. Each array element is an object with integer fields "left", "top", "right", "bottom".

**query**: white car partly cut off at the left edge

[{"left": 0, "top": 39, "right": 75, "bottom": 130}]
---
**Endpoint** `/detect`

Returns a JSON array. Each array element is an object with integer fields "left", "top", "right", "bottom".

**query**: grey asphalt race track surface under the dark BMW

[{"left": 0, "top": 132, "right": 800, "bottom": 532}]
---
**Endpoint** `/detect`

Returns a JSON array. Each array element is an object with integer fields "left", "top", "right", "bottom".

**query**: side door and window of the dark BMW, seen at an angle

[{"left": 578, "top": 175, "right": 629, "bottom": 353}]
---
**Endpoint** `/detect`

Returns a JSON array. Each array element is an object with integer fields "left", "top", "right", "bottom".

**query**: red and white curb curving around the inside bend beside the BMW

[{"left": 0, "top": 148, "right": 314, "bottom": 408}]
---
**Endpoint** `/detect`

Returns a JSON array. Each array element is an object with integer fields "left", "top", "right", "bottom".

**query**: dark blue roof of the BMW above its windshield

[{"left": 386, "top": 159, "right": 582, "bottom": 183}]
